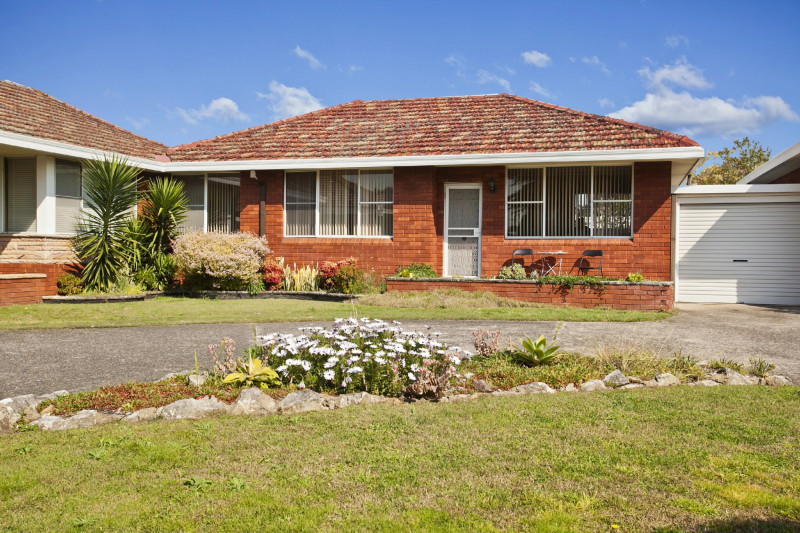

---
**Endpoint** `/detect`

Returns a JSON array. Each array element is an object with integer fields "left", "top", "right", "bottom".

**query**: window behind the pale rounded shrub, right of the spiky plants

[{"left": 173, "top": 174, "right": 239, "bottom": 233}]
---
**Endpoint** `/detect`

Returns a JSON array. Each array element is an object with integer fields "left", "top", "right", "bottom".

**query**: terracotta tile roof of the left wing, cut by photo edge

[{"left": 0, "top": 81, "right": 168, "bottom": 159}]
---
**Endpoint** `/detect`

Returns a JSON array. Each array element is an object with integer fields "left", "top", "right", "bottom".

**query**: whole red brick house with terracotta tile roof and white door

[{"left": 0, "top": 78, "right": 704, "bottom": 304}]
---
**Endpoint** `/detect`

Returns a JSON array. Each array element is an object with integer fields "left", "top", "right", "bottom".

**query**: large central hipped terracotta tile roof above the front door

[{"left": 170, "top": 94, "right": 697, "bottom": 161}]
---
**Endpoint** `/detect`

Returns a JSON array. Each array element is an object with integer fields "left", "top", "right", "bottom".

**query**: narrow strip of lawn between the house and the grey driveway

[{"left": 0, "top": 297, "right": 672, "bottom": 330}]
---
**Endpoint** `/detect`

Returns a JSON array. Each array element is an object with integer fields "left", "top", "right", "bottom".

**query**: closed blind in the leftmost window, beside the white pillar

[{"left": 5, "top": 157, "right": 36, "bottom": 233}]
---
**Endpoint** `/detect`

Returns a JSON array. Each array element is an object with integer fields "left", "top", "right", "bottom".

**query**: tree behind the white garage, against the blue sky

[{"left": 691, "top": 137, "right": 772, "bottom": 185}]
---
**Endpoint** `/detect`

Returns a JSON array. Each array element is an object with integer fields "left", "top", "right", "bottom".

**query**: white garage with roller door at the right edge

[{"left": 675, "top": 143, "right": 800, "bottom": 306}]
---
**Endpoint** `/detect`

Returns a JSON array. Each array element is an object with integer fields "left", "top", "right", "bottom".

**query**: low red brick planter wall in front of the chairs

[{"left": 386, "top": 277, "right": 675, "bottom": 311}]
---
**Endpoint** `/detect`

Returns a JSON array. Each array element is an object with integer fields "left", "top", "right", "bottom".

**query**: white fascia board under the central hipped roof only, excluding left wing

[{"left": 165, "top": 147, "right": 704, "bottom": 172}]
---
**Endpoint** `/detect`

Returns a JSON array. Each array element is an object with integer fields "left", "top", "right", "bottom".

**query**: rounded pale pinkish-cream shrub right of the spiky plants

[{"left": 174, "top": 232, "right": 269, "bottom": 291}]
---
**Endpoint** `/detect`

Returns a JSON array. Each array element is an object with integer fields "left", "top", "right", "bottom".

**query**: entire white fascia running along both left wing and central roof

[{"left": 0, "top": 131, "right": 705, "bottom": 172}]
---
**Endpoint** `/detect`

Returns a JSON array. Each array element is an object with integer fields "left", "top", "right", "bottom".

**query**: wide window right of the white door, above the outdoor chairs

[{"left": 506, "top": 165, "right": 633, "bottom": 238}]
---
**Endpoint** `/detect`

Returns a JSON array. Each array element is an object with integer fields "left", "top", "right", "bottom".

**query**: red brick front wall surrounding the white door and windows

[{"left": 240, "top": 162, "right": 672, "bottom": 280}]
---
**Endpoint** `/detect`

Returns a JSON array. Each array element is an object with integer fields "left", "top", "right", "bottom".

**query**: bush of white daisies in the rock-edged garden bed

[{"left": 251, "top": 318, "right": 471, "bottom": 397}]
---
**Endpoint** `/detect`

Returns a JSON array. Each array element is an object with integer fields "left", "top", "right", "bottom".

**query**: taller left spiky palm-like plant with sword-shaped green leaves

[{"left": 74, "top": 156, "right": 140, "bottom": 291}]
